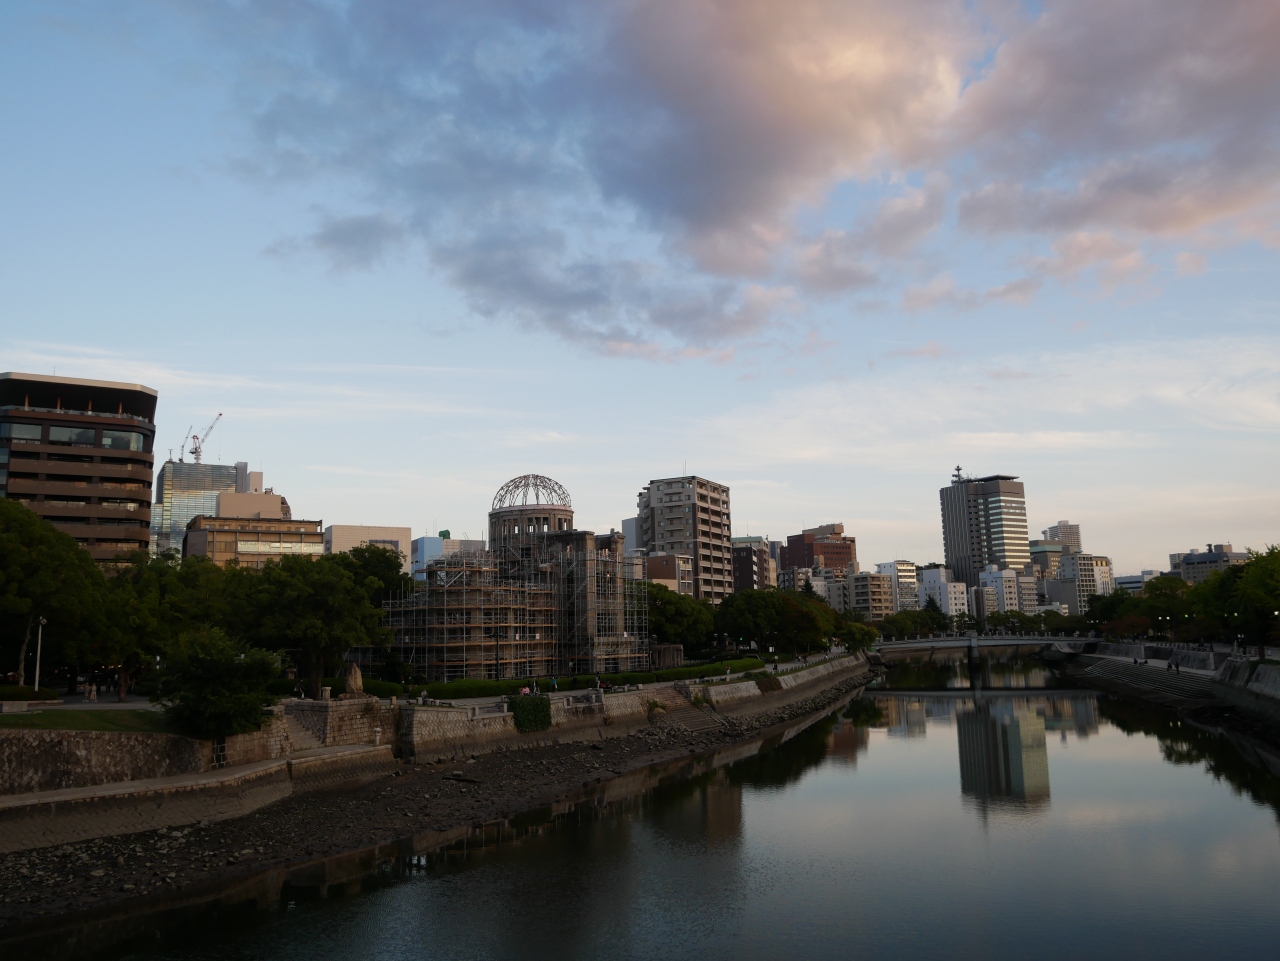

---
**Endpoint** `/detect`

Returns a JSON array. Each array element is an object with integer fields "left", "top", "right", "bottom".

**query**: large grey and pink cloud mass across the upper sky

[{"left": 165, "top": 0, "right": 1280, "bottom": 360}]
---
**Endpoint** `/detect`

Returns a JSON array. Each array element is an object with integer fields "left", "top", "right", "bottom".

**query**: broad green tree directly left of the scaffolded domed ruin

[{"left": 241, "top": 554, "right": 390, "bottom": 697}]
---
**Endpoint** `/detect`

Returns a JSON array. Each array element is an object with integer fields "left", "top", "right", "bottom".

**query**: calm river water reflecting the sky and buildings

[{"left": 120, "top": 662, "right": 1280, "bottom": 961}]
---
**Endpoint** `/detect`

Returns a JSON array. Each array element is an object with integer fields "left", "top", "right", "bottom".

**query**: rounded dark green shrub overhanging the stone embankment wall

[{"left": 151, "top": 628, "right": 280, "bottom": 738}]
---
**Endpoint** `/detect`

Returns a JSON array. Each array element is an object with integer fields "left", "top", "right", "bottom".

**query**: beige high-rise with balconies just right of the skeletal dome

[{"left": 636, "top": 475, "right": 733, "bottom": 604}]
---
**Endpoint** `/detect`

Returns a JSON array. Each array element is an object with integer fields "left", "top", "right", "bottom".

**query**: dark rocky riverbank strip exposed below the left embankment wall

[{"left": 0, "top": 673, "right": 868, "bottom": 956}]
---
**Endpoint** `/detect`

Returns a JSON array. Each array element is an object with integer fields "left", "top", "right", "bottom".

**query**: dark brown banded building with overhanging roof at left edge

[{"left": 0, "top": 372, "right": 156, "bottom": 562}]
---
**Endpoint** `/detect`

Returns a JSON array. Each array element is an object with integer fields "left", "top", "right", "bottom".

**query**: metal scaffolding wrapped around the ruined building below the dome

[{"left": 387, "top": 542, "right": 649, "bottom": 681}]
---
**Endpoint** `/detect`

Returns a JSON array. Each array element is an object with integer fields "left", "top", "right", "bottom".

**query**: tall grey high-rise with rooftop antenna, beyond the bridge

[{"left": 938, "top": 467, "right": 1030, "bottom": 587}]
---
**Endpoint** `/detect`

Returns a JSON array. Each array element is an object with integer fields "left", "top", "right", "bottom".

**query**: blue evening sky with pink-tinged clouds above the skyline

[{"left": 0, "top": 0, "right": 1280, "bottom": 573}]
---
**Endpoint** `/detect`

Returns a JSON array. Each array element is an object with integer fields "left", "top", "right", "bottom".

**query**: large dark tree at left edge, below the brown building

[{"left": 0, "top": 500, "right": 104, "bottom": 685}]
